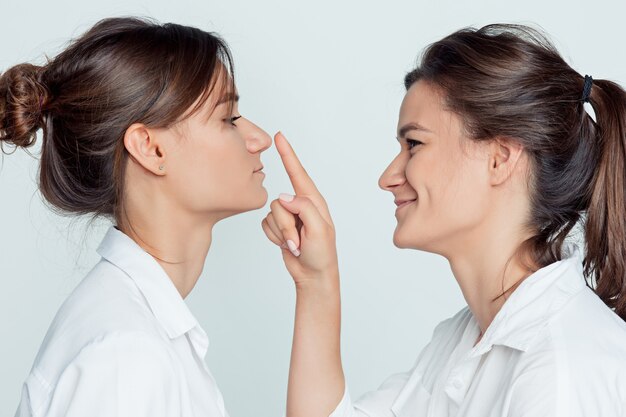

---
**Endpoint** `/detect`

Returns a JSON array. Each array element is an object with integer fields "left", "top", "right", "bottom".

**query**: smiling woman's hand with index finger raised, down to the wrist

[{"left": 261, "top": 132, "right": 337, "bottom": 285}]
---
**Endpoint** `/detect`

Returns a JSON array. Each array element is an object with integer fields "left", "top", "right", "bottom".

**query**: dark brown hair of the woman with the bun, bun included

[{"left": 0, "top": 17, "right": 234, "bottom": 223}]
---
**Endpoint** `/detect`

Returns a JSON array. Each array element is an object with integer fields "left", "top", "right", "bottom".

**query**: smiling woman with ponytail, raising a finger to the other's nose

[{"left": 263, "top": 25, "right": 626, "bottom": 417}]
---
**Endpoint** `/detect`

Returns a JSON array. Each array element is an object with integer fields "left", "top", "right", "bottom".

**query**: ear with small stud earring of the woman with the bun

[{"left": 124, "top": 123, "right": 166, "bottom": 176}]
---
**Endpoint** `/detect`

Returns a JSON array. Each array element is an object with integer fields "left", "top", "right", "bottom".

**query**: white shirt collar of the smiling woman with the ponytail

[{"left": 470, "top": 243, "right": 586, "bottom": 356}]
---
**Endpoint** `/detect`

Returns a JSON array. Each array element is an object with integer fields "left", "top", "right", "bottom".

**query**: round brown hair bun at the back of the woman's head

[{"left": 0, "top": 64, "right": 49, "bottom": 148}]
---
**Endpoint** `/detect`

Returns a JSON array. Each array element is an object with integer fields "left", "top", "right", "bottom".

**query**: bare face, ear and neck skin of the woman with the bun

[{"left": 118, "top": 81, "right": 271, "bottom": 298}]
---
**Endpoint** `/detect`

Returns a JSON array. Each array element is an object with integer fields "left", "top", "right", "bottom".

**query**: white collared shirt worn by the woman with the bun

[{"left": 16, "top": 227, "right": 227, "bottom": 417}]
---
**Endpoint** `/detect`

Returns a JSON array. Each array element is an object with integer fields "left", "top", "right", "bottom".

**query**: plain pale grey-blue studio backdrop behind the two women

[{"left": 0, "top": 0, "right": 626, "bottom": 417}]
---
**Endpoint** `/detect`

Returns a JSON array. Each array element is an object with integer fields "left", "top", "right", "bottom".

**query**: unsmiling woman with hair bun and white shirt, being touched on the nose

[{"left": 0, "top": 18, "right": 271, "bottom": 417}]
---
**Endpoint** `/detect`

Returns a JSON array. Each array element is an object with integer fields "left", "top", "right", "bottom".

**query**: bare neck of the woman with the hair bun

[{"left": 118, "top": 202, "right": 215, "bottom": 298}]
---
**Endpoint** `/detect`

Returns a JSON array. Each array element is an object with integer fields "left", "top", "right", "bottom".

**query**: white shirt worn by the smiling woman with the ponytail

[{"left": 331, "top": 245, "right": 626, "bottom": 417}]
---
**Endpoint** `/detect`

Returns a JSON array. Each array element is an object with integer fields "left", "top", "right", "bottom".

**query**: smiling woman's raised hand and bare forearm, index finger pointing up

[{"left": 262, "top": 132, "right": 345, "bottom": 417}]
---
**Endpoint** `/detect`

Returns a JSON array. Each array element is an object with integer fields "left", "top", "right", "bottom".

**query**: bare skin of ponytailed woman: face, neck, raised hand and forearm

[{"left": 262, "top": 81, "right": 530, "bottom": 417}]
